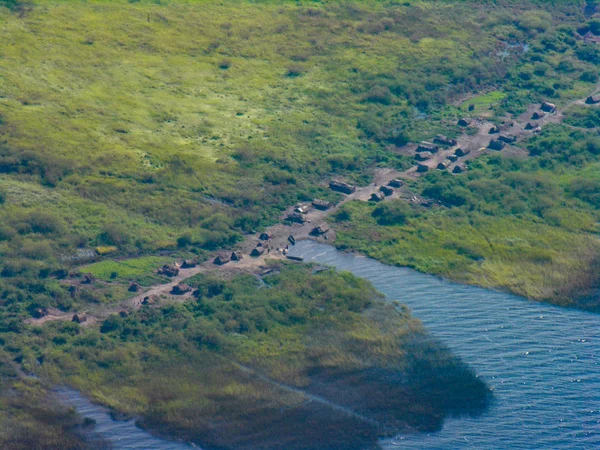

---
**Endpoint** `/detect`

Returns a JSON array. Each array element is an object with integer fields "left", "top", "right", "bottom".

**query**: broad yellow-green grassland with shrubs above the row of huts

[{"left": 0, "top": 0, "right": 598, "bottom": 314}]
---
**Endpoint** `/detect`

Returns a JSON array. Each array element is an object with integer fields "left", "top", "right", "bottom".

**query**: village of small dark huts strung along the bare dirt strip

[{"left": 27, "top": 94, "right": 600, "bottom": 326}]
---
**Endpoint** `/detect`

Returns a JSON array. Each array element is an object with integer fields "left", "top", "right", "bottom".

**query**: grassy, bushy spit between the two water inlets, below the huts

[{"left": 10, "top": 264, "right": 491, "bottom": 449}]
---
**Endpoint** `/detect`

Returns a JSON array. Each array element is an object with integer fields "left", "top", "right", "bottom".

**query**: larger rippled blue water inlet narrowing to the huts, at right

[{"left": 290, "top": 241, "right": 600, "bottom": 449}]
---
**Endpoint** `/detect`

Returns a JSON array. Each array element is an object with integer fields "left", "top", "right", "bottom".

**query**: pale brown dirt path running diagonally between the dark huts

[{"left": 25, "top": 90, "right": 600, "bottom": 326}]
